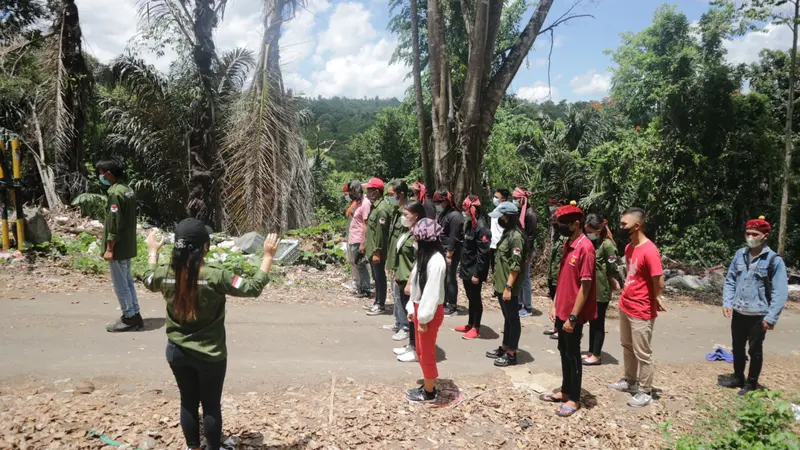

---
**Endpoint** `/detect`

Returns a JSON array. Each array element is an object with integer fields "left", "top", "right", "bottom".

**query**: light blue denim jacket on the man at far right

[{"left": 722, "top": 246, "right": 789, "bottom": 325}]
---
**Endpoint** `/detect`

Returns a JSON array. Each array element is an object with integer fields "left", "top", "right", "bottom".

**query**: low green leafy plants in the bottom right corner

[{"left": 675, "top": 392, "right": 800, "bottom": 450}]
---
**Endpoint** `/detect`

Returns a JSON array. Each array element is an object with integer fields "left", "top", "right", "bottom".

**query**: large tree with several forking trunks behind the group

[{"left": 428, "top": 0, "right": 556, "bottom": 200}]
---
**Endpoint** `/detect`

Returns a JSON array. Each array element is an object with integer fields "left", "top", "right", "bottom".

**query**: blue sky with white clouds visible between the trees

[{"left": 76, "top": 0, "right": 791, "bottom": 101}]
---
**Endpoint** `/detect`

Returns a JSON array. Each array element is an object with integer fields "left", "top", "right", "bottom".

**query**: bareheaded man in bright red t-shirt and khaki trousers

[{"left": 608, "top": 208, "right": 667, "bottom": 408}]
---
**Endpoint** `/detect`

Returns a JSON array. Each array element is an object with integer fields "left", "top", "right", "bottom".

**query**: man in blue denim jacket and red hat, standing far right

[{"left": 722, "top": 216, "right": 789, "bottom": 395}]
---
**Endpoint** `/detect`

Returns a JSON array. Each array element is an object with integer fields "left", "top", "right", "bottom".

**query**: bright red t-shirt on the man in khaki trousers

[{"left": 619, "top": 241, "right": 664, "bottom": 320}]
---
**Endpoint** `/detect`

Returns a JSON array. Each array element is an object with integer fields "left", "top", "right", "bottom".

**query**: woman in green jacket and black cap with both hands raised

[{"left": 144, "top": 219, "right": 278, "bottom": 450}]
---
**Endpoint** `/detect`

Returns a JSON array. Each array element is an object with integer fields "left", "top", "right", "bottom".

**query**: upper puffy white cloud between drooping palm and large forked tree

[{"left": 316, "top": 2, "right": 378, "bottom": 57}]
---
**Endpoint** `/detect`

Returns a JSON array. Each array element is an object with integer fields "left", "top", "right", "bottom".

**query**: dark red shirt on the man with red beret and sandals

[{"left": 556, "top": 234, "right": 597, "bottom": 323}]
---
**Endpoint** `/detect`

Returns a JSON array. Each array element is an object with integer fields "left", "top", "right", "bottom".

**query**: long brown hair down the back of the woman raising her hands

[{"left": 170, "top": 246, "right": 205, "bottom": 323}]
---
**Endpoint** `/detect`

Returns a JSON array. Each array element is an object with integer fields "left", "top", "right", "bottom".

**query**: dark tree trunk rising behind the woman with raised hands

[{"left": 186, "top": 0, "right": 221, "bottom": 229}]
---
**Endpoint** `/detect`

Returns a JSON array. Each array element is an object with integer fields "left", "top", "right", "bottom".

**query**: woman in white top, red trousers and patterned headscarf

[{"left": 406, "top": 218, "right": 447, "bottom": 403}]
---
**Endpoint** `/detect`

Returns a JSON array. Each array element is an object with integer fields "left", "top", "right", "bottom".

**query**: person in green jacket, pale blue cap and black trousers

[{"left": 486, "top": 202, "right": 525, "bottom": 367}]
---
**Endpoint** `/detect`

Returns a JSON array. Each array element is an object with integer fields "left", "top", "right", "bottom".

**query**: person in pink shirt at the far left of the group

[{"left": 346, "top": 180, "right": 371, "bottom": 298}]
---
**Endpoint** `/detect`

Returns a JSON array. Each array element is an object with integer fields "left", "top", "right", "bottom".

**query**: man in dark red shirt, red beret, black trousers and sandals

[{"left": 539, "top": 202, "right": 597, "bottom": 417}]
